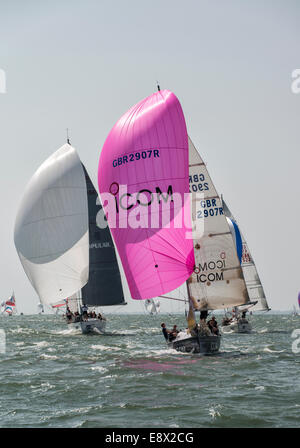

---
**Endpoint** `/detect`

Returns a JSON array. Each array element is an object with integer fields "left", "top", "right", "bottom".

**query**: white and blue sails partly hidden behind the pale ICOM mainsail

[{"left": 222, "top": 198, "right": 270, "bottom": 311}]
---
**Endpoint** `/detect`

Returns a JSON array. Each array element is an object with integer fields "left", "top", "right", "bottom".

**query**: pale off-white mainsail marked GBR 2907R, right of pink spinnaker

[{"left": 187, "top": 139, "right": 249, "bottom": 310}]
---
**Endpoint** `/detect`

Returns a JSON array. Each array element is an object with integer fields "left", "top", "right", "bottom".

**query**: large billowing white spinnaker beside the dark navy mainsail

[{"left": 14, "top": 144, "right": 89, "bottom": 304}]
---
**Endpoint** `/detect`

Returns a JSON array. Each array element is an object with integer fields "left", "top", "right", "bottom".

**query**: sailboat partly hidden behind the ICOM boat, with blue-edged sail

[{"left": 222, "top": 197, "right": 270, "bottom": 333}]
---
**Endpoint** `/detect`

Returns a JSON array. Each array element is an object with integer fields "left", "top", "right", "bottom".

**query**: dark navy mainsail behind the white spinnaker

[{"left": 81, "top": 165, "right": 125, "bottom": 306}]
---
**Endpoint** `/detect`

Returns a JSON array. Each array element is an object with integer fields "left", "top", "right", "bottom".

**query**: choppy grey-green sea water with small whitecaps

[{"left": 0, "top": 313, "right": 300, "bottom": 428}]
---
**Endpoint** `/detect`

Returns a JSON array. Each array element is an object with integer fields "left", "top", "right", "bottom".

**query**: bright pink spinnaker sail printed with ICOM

[{"left": 98, "top": 90, "right": 194, "bottom": 299}]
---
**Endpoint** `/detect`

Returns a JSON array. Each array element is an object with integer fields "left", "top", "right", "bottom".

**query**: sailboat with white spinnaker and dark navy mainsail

[{"left": 14, "top": 140, "right": 125, "bottom": 333}]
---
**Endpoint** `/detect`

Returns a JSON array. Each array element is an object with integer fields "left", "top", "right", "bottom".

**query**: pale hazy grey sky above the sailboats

[{"left": 0, "top": 0, "right": 300, "bottom": 313}]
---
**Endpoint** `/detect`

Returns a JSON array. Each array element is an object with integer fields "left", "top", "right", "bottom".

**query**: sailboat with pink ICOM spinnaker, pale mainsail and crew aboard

[{"left": 98, "top": 89, "right": 249, "bottom": 353}]
